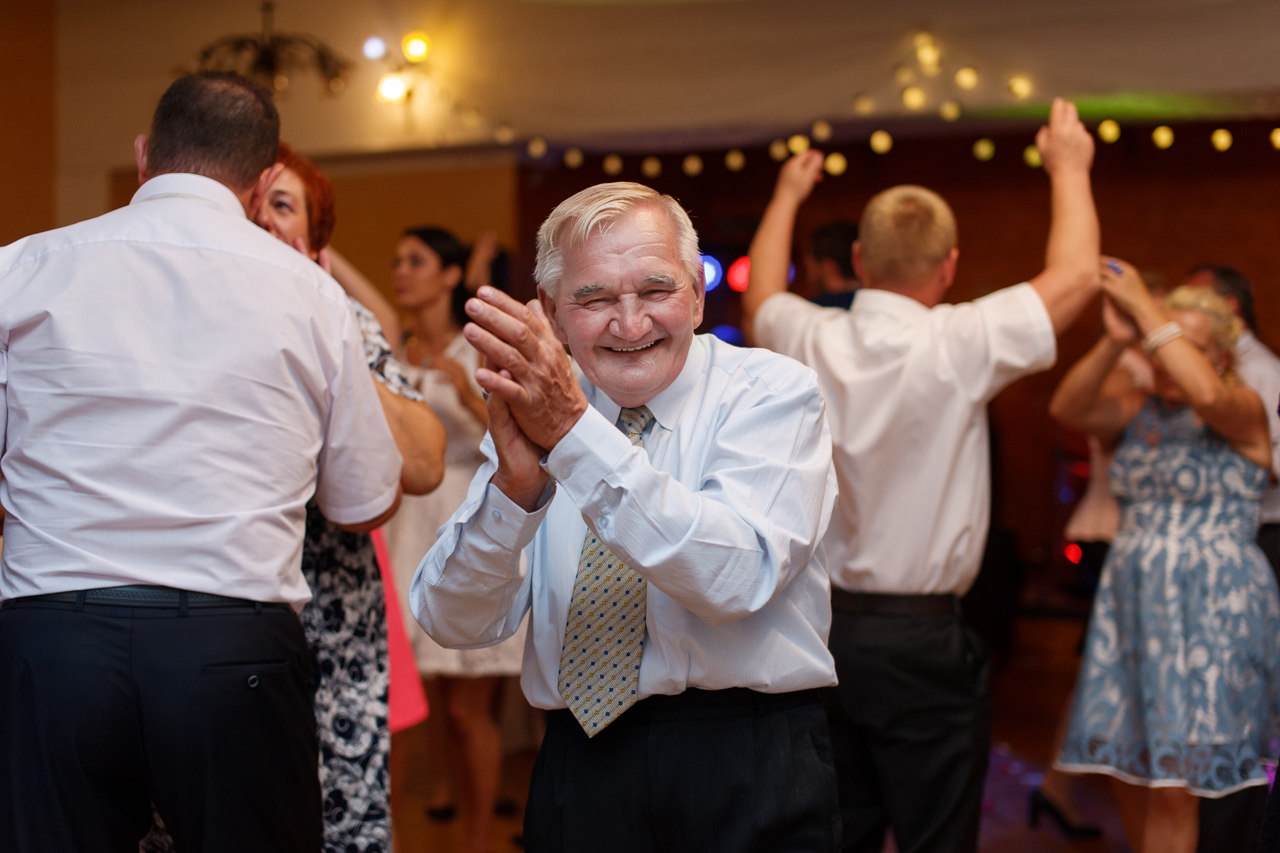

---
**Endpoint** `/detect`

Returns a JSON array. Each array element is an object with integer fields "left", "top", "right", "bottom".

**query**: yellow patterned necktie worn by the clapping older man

[{"left": 559, "top": 406, "right": 653, "bottom": 738}]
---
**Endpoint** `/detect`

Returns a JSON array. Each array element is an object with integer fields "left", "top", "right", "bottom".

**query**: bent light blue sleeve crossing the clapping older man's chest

[{"left": 545, "top": 368, "right": 836, "bottom": 626}]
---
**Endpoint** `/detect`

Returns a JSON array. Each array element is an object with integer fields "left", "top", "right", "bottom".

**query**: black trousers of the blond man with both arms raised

[{"left": 827, "top": 610, "right": 991, "bottom": 853}]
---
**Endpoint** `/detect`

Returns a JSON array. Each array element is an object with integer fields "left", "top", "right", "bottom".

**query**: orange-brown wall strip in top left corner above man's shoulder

[{"left": 0, "top": 0, "right": 56, "bottom": 246}]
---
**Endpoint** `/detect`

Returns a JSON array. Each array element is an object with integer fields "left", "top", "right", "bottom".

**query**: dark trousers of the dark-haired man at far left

[{"left": 0, "top": 599, "right": 321, "bottom": 853}]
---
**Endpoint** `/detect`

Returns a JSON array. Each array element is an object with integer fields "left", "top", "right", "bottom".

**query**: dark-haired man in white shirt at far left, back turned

[{"left": 0, "top": 74, "right": 401, "bottom": 853}]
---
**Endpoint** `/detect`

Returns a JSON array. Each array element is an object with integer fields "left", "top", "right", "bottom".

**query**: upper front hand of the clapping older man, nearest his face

[{"left": 462, "top": 287, "right": 586, "bottom": 450}]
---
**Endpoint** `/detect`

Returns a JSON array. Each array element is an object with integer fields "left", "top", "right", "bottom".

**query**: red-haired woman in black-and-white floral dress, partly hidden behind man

[{"left": 142, "top": 142, "right": 445, "bottom": 853}]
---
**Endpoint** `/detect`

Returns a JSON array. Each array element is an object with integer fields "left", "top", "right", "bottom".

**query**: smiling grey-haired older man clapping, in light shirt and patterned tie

[{"left": 410, "top": 183, "right": 840, "bottom": 853}]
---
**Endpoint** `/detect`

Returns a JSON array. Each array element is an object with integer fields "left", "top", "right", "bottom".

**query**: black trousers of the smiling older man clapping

[{"left": 525, "top": 689, "right": 840, "bottom": 853}]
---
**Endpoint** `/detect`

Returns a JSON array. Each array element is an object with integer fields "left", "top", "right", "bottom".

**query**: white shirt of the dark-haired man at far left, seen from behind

[{"left": 0, "top": 174, "right": 397, "bottom": 603}]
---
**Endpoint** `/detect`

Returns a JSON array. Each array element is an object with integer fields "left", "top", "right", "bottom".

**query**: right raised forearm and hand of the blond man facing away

[{"left": 1030, "top": 97, "right": 1100, "bottom": 334}]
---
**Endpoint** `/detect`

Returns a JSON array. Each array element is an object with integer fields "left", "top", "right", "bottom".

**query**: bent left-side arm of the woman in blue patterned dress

[{"left": 1048, "top": 292, "right": 1143, "bottom": 444}]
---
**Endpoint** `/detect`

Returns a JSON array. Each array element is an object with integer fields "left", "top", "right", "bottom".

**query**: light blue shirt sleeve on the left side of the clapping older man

[{"left": 408, "top": 435, "right": 556, "bottom": 648}]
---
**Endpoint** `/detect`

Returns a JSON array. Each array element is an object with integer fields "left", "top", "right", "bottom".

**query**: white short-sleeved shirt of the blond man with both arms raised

[{"left": 755, "top": 279, "right": 1056, "bottom": 593}]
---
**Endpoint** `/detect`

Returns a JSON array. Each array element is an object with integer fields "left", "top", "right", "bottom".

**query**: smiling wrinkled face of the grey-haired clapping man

[{"left": 539, "top": 204, "right": 703, "bottom": 407}]
